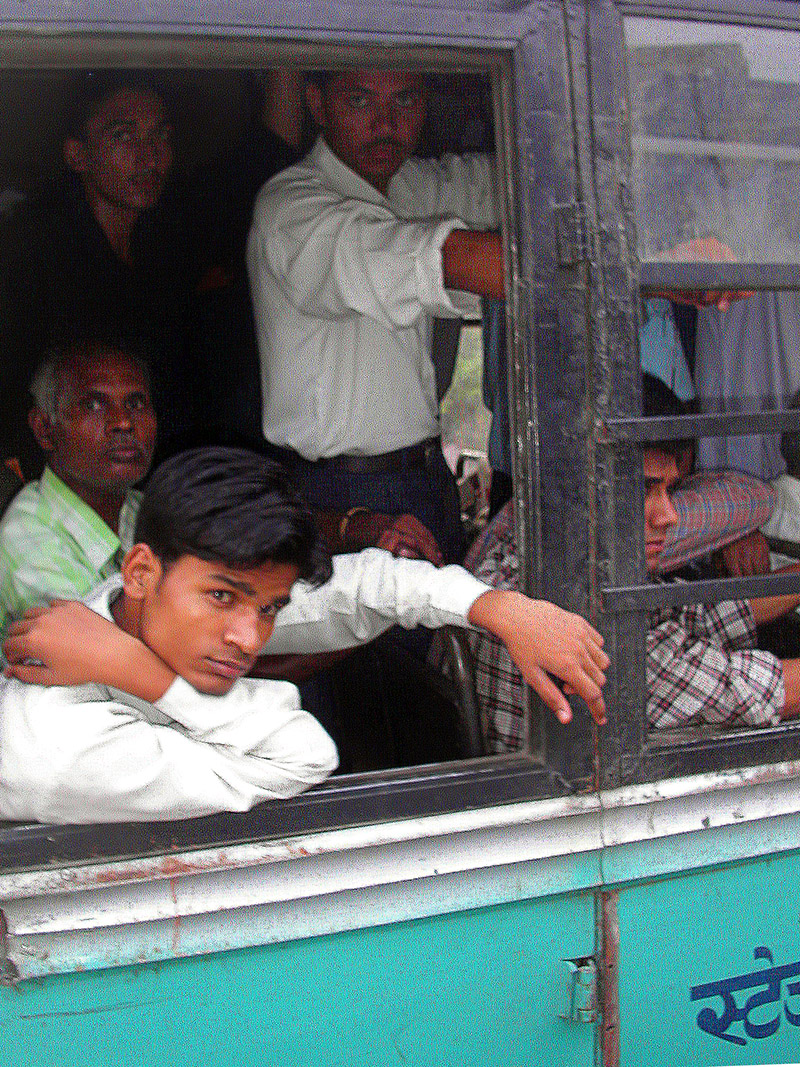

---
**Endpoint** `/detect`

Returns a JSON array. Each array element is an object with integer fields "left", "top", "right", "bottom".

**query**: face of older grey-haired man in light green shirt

[{"left": 34, "top": 352, "right": 156, "bottom": 499}]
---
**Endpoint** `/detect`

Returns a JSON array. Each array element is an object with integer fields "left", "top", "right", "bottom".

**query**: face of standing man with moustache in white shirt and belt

[{"left": 308, "top": 70, "right": 426, "bottom": 193}]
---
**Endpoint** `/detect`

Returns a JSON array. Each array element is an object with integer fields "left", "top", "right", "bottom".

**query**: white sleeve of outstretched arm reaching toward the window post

[{"left": 263, "top": 548, "right": 489, "bottom": 655}]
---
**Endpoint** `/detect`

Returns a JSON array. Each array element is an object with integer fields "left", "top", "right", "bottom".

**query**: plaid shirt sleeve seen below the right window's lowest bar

[{"left": 646, "top": 601, "right": 785, "bottom": 730}]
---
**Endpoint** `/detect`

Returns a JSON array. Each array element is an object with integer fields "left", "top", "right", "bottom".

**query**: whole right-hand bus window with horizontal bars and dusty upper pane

[{"left": 608, "top": 17, "right": 800, "bottom": 775}]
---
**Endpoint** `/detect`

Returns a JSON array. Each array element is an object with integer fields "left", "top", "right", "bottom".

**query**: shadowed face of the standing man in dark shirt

[{"left": 64, "top": 89, "right": 173, "bottom": 214}]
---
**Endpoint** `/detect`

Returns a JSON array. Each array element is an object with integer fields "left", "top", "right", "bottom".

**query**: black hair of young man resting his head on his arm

[{"left": 135, "top": 447, "right": 331, "bottom": 585}]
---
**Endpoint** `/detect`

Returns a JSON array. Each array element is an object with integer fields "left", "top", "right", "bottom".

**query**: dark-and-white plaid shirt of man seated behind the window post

[{"left": 465, "top": 505, "right": 784, "bottom": 752}]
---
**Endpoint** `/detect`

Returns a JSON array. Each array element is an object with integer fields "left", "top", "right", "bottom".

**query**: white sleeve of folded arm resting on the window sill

[{"left": 0, "top": 679, "right": 337, "bottom": 823}]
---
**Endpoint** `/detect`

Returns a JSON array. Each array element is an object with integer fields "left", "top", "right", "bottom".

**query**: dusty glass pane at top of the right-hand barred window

[{"left": 624, "top": 18, "right": 800, "bottom": 262}]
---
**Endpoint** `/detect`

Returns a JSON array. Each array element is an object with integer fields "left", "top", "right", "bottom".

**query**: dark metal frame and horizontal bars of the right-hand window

[{"left": 587, "top": 0, "right": 800, "bottom": 787}]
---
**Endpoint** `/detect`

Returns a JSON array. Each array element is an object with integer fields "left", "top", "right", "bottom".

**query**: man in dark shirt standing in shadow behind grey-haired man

[{"left": 0, "top": 70, "right": 199, "bottom": 476}]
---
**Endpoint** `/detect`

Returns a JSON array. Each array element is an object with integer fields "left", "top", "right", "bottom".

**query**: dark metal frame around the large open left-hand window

[{"left": 0, "top": 0, "right": 591, "bottom": 870}]
